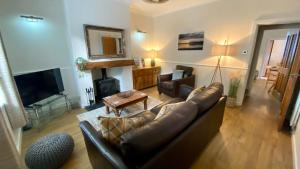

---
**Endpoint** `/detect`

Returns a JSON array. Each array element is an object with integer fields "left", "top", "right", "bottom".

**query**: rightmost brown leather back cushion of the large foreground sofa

[{"left": 188, "top": 83, "right": 224, "bottom": 115}]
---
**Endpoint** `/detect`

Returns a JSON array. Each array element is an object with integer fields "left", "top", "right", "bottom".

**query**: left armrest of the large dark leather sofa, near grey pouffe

[{"left": 80, "top": 121, "right": 129, "bottom": 169}]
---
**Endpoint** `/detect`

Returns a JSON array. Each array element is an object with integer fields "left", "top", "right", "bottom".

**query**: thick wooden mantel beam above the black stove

[{"left": 85, "top": 59, "right": 135, "bottom": 70}]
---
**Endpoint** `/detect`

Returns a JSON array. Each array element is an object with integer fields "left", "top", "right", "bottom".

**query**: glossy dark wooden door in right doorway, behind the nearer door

[{"left": 275, "top": 30, "right": 299, "bottom": 101}]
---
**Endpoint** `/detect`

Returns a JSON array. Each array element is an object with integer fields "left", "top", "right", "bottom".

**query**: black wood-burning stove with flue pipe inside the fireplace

[{"left": 94, "top": 68, "right": 120, "bottom": 103}]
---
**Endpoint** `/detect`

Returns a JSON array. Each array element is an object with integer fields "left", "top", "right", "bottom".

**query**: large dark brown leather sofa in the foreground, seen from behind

[{"left": 80, "top": 83, "right": 226, "bottom": 169}]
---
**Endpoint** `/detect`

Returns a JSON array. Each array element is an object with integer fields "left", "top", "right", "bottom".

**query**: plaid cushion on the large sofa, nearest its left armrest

[{"left": 100, "top": 111, "right": 155, "bottom": 146}]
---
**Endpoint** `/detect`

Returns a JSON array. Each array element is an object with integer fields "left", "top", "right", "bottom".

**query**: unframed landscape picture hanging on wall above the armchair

[{"left": 178, "top": 32, "right": 204, "bottom": 50}]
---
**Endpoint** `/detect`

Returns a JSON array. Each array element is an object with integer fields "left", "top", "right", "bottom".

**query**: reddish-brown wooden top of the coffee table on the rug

[{"left": 103, "top": 90, "right": 148, "bottom": 108}]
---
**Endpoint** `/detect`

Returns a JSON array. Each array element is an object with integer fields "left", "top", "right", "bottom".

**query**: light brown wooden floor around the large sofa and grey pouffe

[{"left": 23, "top": 81, "right": 292, "bottom": 169}]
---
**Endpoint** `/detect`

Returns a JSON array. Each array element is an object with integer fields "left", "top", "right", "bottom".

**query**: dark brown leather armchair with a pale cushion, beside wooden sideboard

[{"left": 157, "top": 65, "right": 195, "bottom": 97}]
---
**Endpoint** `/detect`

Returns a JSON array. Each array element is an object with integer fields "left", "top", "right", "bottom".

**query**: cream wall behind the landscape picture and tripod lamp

[{"left": 154, "top": 0, "right": 300, "bottom": 104}]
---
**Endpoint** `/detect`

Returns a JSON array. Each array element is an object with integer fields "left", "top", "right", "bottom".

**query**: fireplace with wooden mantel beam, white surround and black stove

[{"left": 78, "top": 59, "right": 134, "bottom": 111}]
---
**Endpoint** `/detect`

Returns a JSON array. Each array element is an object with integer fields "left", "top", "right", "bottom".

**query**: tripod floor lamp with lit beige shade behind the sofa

[{"left": 211, "top": 40, "right": 228, "bottom": 83}]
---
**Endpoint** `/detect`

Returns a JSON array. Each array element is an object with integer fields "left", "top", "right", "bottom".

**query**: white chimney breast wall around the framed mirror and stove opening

[{"left": 64, "top": 0, "right": 133, "bottom": 106}]
